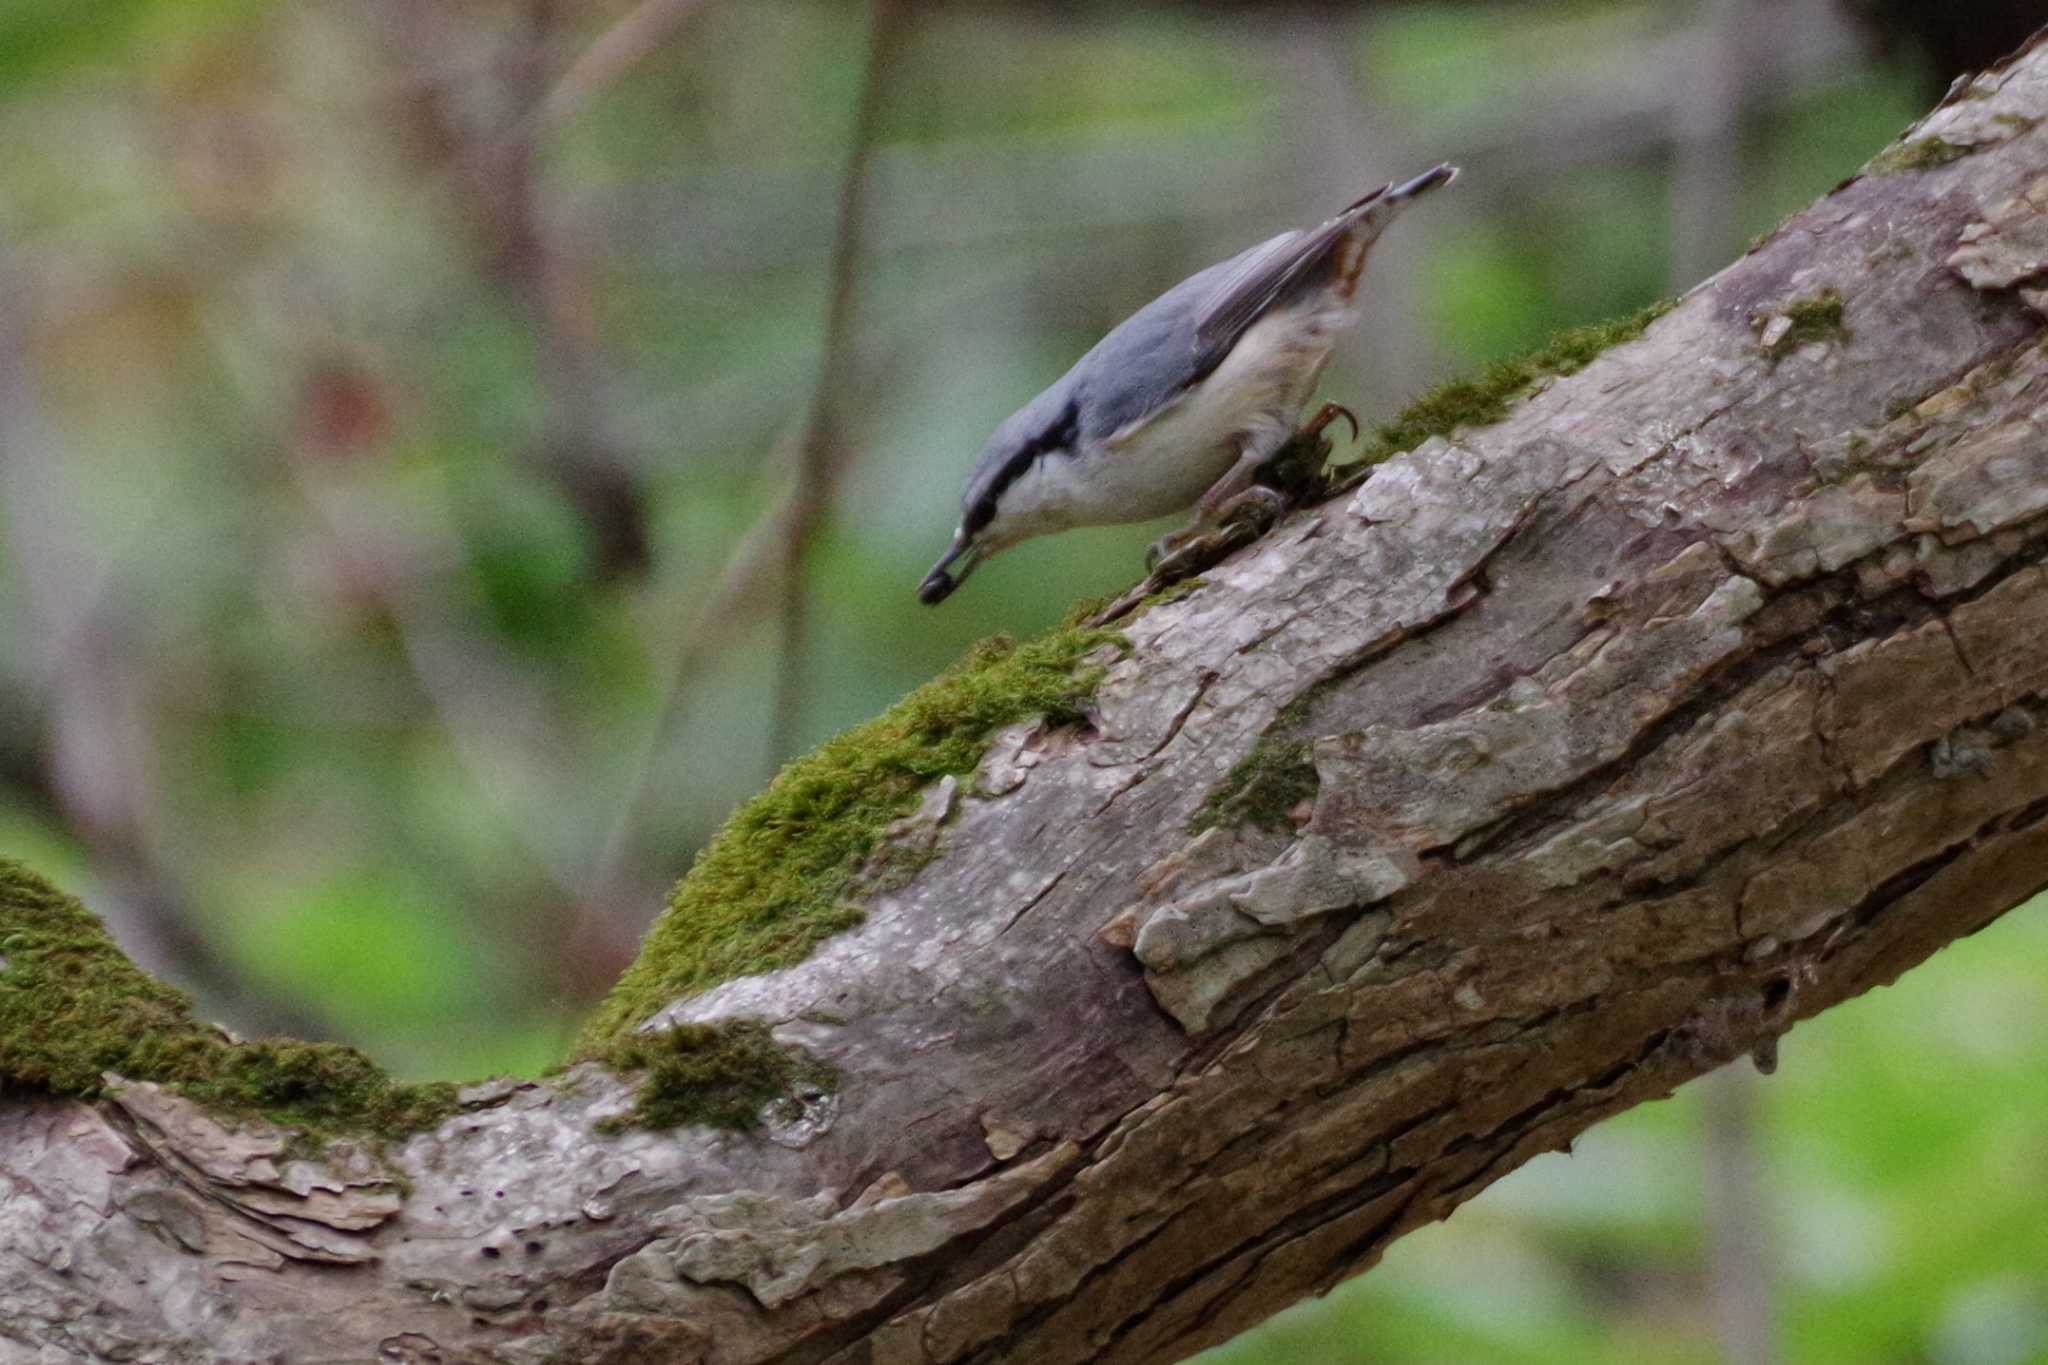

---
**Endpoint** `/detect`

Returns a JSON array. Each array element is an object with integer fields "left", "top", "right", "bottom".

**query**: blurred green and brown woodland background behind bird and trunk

[{"left": 0, "top": 0, "right": 2048, "bottom": 1365}]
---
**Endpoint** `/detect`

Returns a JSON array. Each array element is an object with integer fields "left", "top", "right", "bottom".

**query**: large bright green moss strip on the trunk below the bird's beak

[{"left": 582, "top": 624, "right": 1122, "bottom": 1060}]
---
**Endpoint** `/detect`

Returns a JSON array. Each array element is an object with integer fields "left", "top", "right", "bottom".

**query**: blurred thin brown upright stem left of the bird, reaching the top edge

[{"left": 768, "top": 0, "right": 909, "bottom": 767}]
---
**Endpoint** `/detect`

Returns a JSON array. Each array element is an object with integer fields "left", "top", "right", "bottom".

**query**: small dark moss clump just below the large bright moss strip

[{"left": 598, "top": 1019, "right": 834, "bottom": 1132}]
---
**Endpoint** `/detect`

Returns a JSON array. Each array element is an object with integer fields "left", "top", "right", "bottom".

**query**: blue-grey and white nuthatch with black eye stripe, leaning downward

[{"left": 918, "top": 166, "right": 1458, "bottom": 604}]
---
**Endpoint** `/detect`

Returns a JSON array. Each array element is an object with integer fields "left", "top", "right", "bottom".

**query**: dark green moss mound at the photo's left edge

[{"left": 0, "top": 860, "right": 455, "bottom": 1138}]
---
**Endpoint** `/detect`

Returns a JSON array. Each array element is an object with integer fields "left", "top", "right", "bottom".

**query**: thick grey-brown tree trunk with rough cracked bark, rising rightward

[{"left": 0, "top": 40, "right": 2048, "bottom": 1365}]
